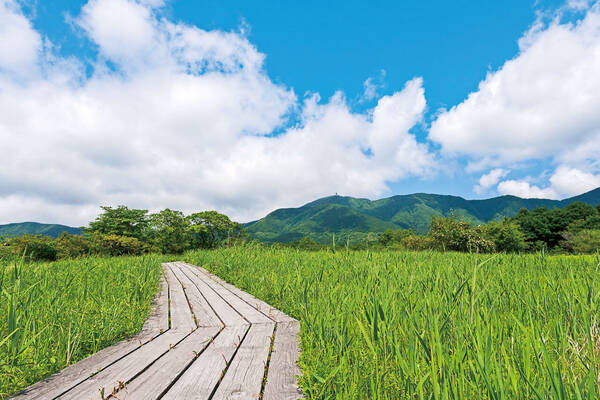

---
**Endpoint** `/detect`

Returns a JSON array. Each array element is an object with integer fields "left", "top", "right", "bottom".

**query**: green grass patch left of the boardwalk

[{"left": 0, "top": 256, "right": 160, "bottom": 398}]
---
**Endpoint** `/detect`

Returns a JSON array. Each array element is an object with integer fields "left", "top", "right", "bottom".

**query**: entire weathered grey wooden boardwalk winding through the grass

[{"left": 14, "top": 262, "right": 301, "bottom": 400}]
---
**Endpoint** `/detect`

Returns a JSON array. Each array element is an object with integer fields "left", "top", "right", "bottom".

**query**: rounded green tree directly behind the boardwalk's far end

[{"left": 149, "top": 208, "right": 189, "bottom": 254}]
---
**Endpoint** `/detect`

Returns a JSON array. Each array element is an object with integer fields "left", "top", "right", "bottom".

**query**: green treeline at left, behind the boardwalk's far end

[{"left": 0, "top": 206, "right": 246, "bottom": 261}]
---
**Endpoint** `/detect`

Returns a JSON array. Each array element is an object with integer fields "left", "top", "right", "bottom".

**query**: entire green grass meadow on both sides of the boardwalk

[{"left": 0, "top": 245, "right": 600, "bottom": 400}]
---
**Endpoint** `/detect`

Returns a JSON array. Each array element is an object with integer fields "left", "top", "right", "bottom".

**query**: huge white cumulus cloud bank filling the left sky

[{"left": 0, "top": 0, "right": 436, "bottom": 224}]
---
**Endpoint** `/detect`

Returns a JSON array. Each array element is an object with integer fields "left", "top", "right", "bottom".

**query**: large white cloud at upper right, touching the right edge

[{"left": 429, "top": 2, "right": 600, "bottom": 169}]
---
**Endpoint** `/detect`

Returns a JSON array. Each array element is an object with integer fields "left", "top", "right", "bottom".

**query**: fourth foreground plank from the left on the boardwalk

[{"left": 162, "top": 325, "right": 250, "bottom": 400}]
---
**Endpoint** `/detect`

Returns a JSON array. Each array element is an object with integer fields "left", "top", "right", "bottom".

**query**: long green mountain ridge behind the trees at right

[{"left": 245, "top": 188, "right": 600, "bottom": 242}]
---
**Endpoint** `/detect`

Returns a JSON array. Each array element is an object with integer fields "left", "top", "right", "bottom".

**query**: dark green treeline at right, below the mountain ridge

[{"left": 286, "top": 202, "right": 600, "bottom": 253}]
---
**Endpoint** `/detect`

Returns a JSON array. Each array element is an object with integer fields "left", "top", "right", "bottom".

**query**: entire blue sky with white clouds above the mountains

[{"left": 0, "top": 0, "right": 600, "bottom": 226}]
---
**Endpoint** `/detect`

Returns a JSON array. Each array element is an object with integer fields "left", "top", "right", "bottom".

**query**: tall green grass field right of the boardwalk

[{"left": 185, "top": 247, "right": 600, "bottom": 400}]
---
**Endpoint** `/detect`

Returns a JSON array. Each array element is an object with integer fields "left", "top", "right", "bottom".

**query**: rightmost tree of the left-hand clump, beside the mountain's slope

[{"left": 186, "top": 211, "right": 244, "bottom": 249}]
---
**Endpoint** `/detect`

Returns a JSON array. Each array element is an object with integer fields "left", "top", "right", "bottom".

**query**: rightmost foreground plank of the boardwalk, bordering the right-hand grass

[{"left": 263, "top": 321, "right": 302, "bottom": 400}]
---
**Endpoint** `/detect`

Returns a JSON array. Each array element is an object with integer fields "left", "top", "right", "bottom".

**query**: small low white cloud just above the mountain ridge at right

[{"left": 498, "top": 165, "right": 600, "bottom": 199}]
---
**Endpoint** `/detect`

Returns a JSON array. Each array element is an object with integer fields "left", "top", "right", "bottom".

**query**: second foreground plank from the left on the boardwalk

[{"left": 59, "top": 329, "right": 189, "bottom": 400}]
